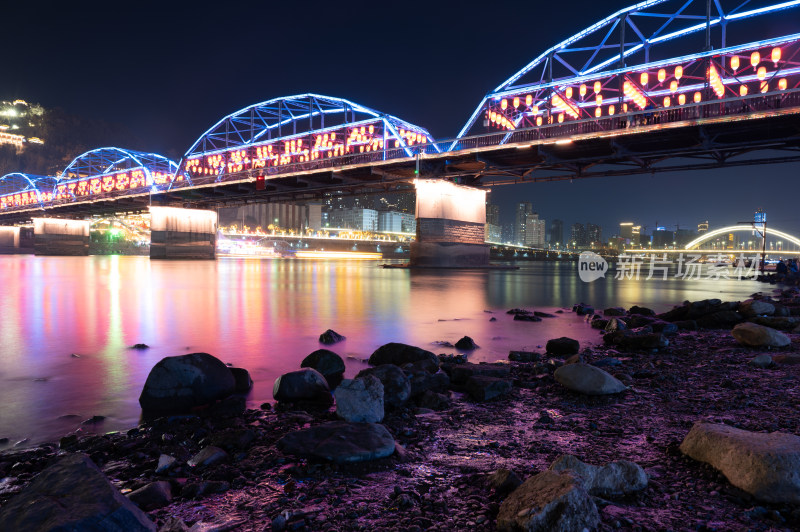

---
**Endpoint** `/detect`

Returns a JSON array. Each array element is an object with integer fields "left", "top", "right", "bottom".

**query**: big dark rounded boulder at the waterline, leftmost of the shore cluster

[{"left": 139, "top": 353, "right": 236, "bottom": 412}]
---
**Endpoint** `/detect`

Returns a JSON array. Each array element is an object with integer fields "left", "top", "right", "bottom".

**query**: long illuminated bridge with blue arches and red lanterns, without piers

[{"left": 0, "top": 0, "right": 800, "bottom": 260}]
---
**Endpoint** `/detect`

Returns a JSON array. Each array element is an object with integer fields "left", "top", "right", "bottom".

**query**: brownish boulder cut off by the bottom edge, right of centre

[{"left": 497, "top": 471, "right": 600, "bottom": 532}]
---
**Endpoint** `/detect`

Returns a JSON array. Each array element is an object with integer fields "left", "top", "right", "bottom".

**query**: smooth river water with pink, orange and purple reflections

[{"left": 0, "top": 255, "right": 769, "bottom": 449}]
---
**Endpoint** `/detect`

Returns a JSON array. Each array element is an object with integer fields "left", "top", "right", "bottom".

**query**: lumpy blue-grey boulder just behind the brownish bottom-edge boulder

[{"left": 550, "top": 454, "right": 647, "bottom": 497}]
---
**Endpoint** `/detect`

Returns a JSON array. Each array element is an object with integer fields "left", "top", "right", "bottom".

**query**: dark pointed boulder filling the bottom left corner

[{"left": 0, "top": 454, "right": 156, "bottom": 532}]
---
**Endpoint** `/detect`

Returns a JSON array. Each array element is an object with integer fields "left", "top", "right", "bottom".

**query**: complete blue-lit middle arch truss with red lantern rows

[{"left": 179, "top": 94, "right": 439, "bottom": 185}]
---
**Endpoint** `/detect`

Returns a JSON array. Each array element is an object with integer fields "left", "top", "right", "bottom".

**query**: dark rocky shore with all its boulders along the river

[{"left": 0, "top": 288, "right": 800, "bottom": 531}]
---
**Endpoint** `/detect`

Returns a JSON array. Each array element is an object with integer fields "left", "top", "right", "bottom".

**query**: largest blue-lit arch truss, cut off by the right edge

[{"left": 451, "top": 0, "right": 800, "bottom": 141}]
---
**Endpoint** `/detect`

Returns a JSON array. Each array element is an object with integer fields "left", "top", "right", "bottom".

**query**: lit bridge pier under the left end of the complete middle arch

[{"left": 150, "top": 207, "right": 217, "bottom": 260}]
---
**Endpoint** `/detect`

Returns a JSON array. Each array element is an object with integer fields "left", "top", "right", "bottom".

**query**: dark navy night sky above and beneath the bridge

[{"left": 6, "top": 0, "right": 800, "bottom": 237}]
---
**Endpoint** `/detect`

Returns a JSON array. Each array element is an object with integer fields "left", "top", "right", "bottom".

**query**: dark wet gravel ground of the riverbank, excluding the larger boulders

[{"left": 0, "top": 291, "right": 800, "bottom": 530}]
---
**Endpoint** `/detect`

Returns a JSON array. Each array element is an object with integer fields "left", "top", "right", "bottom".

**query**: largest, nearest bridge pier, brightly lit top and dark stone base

[{"left": 409, "top": 179, "right": 489, "bottom": 268}]
